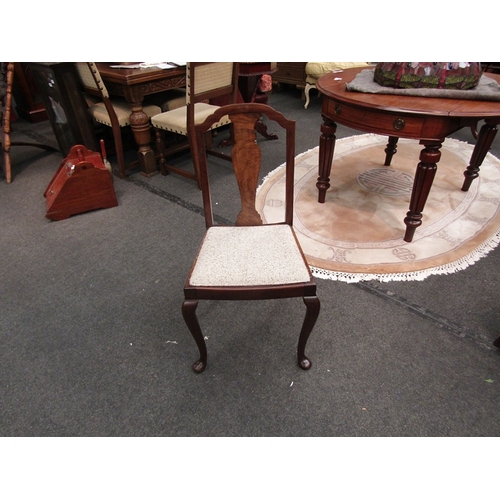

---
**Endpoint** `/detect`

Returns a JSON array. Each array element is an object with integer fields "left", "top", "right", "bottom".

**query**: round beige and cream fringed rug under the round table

[{"left": 257, "top": 134, "right": 500, "bottom": 282}]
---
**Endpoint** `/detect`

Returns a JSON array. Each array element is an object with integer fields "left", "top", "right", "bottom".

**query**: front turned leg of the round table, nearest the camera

[{"left": 404, "top": 139, "right": 444, "bottom": 242}]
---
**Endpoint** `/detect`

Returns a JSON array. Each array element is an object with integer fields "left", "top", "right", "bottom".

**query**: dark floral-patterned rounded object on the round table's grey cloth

[{"left": 374, "top": 62, "right": 482, "bottom": 90}]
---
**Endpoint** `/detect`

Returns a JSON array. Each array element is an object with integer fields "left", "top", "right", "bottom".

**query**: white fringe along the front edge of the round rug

[{"left": 309, "top": 228, "right": 500, "bottom": 283}]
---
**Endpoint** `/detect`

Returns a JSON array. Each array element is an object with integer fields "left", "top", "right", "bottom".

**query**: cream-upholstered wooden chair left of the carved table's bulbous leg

[{"left": 76, "top": 62, "right": 161, "bottom": 179}]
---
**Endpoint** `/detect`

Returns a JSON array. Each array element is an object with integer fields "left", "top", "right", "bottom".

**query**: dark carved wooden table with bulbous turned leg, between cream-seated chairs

[{"left": 97, "top": 63, "right": 186, "bottom": 177}]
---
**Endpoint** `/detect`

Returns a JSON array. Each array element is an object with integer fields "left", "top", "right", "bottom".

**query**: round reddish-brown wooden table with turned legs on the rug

[{"left": 316, "top": 68, "right": 500, "bottom": 242}]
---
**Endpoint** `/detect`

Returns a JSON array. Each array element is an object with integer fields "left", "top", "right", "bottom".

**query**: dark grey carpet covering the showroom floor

[{"left": 0, "top": 84, "right": 500, "bottom": 436}]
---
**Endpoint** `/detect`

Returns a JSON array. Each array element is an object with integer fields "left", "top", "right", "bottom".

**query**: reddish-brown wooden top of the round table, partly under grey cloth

[{"left": 316, "top": 68, "right": 500, "bottom": 118}]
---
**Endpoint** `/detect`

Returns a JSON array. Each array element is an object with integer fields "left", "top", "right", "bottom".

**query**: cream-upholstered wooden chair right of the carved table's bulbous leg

[{"left": 151, "top": 62, "right": 239, "bottom": 187}]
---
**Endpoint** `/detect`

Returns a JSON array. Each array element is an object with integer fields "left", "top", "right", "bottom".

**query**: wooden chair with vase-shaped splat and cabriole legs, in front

[{"left": 182, "top": 103, "right": 320, "bottom": 373}]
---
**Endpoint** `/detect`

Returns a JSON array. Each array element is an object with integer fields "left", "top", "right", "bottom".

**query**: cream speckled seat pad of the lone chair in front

[{"left": 189, "top": 225, "right": 311, "bottom": 286}]
